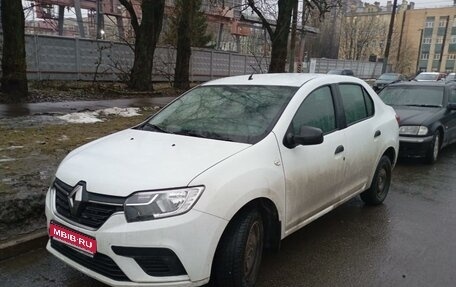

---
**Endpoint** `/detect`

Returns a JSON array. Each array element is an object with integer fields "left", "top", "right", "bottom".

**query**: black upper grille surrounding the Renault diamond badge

[{"left": 54, "top": 179, "right": 125, "bottom": 228}]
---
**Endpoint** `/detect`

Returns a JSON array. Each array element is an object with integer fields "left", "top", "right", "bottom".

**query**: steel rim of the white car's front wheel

[{"left": 244, "top": 221, "right": 261, "bottom": 282}]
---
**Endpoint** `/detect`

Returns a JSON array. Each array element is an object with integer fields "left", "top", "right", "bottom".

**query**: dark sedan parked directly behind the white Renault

[{"left": 380, "top": 82, "right": 456, "bottom": 163}]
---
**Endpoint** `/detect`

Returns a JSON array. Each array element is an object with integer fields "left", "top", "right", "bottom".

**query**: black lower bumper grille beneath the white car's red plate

[{"left": 51, "top": 239, "right": 131, "bottom": 281}]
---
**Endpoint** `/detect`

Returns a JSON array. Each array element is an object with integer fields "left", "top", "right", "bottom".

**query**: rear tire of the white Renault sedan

[{"left": 361, "top": 155, "right": 391, "bottom": 205}]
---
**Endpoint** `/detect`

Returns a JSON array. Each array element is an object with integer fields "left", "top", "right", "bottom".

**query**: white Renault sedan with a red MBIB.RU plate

[{"left": 46, "top": 74, "right": 399, "bottom": 286}]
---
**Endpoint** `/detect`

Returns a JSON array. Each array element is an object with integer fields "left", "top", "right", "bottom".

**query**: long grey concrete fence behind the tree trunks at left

[{"left": 1, "top": 35, "right": 269, "bottom": 81}]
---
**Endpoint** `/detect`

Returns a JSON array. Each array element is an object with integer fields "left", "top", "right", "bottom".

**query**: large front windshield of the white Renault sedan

[{"left": 141, "top": 86, "right": 298, "bottom": 144}]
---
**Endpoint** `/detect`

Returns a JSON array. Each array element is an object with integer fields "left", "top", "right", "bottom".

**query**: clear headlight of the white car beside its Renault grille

[{"left": 125, "top": 186, "right": 204, "bottom": 222}]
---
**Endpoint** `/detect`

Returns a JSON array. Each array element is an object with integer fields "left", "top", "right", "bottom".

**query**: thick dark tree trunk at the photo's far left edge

[{"left": 1, "top": 0, "right": 28, "bottom": 102}]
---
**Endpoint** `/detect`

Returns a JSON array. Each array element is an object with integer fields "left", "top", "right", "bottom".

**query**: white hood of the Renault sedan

[{"left": 56, "top": 129, "right": 251, "bottom": 196}]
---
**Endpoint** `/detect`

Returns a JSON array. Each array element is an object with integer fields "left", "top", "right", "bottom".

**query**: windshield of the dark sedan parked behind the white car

[{"left": 379, "top": 86, "right": 444, "bottom": 107}]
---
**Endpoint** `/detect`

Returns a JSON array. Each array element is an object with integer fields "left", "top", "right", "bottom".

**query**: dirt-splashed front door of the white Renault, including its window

[{"left": 280, "top": 86, "right": 344, "bottom": 232}]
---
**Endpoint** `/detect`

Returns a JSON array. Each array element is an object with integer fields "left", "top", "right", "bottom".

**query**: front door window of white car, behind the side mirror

[{"left": 291, "top": 86, "right": 336, "bottom": 134}]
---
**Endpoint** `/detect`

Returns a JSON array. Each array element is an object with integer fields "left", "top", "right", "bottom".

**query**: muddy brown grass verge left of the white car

[{"left": 0, "top": 108, "right": 154, "bottom": 242}]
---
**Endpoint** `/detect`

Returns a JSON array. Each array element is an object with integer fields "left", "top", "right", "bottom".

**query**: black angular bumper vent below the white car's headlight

[{"left": 112, "top": 246, "right": 187, "bottom": 277}]
